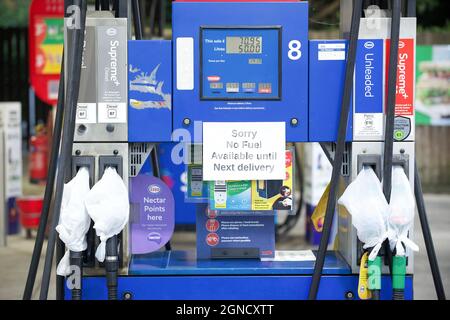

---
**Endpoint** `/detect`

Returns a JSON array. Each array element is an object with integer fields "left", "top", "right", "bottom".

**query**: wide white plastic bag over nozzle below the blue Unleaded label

[{"left": 338, "top": 167, "right": 389, "bottom": 260}]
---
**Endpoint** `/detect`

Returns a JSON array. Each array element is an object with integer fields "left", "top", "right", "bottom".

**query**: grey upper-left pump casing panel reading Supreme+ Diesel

[{"left": 64, "top": 11, "right": 128, "bottom": 142}]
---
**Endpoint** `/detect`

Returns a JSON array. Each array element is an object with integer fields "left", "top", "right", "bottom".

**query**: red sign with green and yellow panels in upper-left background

[{"left": 28, "top": 0, "right": 64, "bottom": 105}]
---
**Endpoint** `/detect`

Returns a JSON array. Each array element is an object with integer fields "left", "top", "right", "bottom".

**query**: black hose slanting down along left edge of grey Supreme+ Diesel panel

[{"left": 39, "top": 0, "right": 87, "bottom": 300}]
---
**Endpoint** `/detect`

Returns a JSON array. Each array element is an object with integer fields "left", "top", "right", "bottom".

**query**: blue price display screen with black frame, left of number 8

[{"left": 200, "top": 27, "right": 281, "bottom": 100}]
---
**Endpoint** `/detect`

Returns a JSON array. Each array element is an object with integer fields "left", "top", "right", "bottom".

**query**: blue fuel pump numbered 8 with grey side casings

[{"left": 25, "top": 0, "right": 446, "bottom": 300}]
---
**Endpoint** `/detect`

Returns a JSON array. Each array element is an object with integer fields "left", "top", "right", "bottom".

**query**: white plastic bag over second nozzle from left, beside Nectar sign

[{"left": 84, "top": 168, "right": 130, "bottom": 262}]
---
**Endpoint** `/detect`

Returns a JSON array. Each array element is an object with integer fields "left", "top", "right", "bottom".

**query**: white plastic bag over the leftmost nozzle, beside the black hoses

[{"left": 56, "top": 168, "right": 91, "bottom": 276}]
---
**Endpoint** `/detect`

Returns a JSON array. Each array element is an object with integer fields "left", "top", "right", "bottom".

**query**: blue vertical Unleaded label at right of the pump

[{"left": 355, "top": 39, "right": 384, "bottom": 113}]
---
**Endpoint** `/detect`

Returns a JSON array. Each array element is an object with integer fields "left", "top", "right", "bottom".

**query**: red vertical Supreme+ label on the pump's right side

[{"left": 386, "top": 39, "right": 415, "bottom": 116}]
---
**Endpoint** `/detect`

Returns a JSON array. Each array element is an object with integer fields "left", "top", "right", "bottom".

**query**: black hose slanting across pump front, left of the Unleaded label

[{"left": 308, "top": 0, "right": 363, "bottom": 300}]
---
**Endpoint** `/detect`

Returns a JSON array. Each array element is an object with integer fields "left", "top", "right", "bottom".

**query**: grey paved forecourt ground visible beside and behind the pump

[{"left": 0, "top": 195, "right": 450, "bottom": 299}]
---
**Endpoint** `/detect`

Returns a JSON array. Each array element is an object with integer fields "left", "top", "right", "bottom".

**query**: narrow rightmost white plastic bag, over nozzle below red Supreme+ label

[{"left": 388, "top": 166, "right": 419, "bottom": 256}]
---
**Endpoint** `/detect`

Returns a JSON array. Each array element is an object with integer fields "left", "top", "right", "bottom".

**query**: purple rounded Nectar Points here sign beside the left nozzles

[{"left": 130, "top": 175, "right": 175, "bottom": 254}]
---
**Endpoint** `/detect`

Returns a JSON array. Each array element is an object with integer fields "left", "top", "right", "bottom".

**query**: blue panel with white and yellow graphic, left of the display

[{"left": 128, "top": 40, "right": 172, "bottom": 142}]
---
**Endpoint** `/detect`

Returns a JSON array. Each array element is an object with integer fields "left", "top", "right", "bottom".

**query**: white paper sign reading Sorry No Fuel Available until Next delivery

[{"left": 203, "top": 122, "right": 286, "bottom": 181}]
